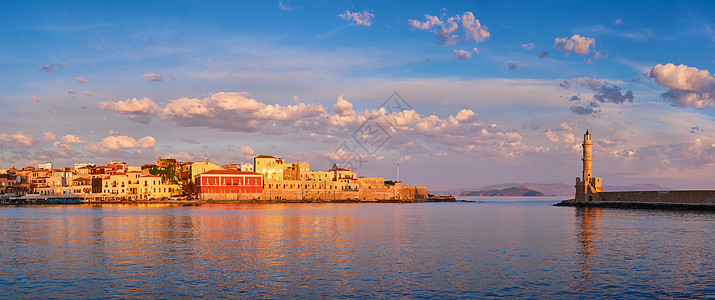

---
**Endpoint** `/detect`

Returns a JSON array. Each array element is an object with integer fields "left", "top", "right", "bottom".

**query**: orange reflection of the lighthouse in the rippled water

[{"left": 576, "top": 207, "right": 601, "bottom": 292}]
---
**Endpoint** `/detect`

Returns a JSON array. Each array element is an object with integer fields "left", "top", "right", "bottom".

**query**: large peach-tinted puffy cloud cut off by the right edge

[{"left": 649, "top": 63, "right": 715, "bottom": 109}]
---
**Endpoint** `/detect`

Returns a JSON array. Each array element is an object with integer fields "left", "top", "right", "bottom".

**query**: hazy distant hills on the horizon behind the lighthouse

[{"left": 459, "top": 182, "right": 672, "bottom": 196}]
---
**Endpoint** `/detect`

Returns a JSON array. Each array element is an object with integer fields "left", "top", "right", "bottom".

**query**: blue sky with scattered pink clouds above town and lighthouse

[{"left": 0, "top": 0, "right": 715, "bottom": 190}]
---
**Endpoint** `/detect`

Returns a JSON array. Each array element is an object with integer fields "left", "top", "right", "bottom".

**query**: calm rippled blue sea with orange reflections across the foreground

[{"left": 0, "top": 197, "right": 715, "bottom": 299}]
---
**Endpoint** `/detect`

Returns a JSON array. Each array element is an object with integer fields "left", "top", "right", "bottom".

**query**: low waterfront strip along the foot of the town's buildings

[{"left": 0, "top": 196, "right": 458, "bottom": 206}]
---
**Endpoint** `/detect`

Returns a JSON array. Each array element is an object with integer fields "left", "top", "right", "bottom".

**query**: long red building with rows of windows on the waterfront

[{"left": 194, "top": 170, "right": 263, "bottom": 200}]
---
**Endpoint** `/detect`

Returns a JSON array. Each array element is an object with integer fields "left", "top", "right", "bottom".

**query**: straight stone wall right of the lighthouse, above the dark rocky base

[{"left": 593, "top": 190, "right": 715, "bottom": 204}]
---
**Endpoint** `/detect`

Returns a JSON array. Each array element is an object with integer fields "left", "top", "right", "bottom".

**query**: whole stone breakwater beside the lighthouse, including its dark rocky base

[{"left": 556, "top": 190, "right": 715, "bottom": 210}]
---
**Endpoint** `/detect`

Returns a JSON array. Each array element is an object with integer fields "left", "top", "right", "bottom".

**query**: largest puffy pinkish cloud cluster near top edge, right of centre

[{"left": 408, "top": 11, "right": 490, "bottom": 46}]
